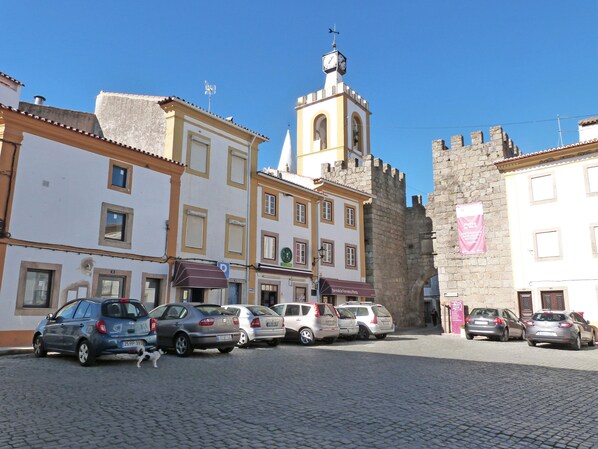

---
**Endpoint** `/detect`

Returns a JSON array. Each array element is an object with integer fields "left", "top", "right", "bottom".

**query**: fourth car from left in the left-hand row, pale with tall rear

[{"left": 271, "top": 302, "right": 339, "bottom": 345}]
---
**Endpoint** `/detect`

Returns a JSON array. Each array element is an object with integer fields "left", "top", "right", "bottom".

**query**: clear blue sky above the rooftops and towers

[{"left": 0, "top": 0, "right": 598, "bottom": 205}]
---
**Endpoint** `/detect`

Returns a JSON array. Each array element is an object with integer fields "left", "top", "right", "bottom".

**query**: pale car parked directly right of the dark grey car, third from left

[{"left": 222, "top": 304, "right": 285, "bottom": 348}]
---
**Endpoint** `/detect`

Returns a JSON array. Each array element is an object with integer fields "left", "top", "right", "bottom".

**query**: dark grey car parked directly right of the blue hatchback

[{"left": 150, "top": 302, "right": 241, "bottom": 357}]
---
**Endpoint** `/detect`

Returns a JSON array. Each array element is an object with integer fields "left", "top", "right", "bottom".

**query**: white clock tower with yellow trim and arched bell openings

[{"left": 295, "top": 43, "right": 370, "bottom": 178}]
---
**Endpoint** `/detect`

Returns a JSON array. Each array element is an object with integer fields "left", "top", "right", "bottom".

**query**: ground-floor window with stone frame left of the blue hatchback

[{"left": 15, "top": 261, "right": 62, "bottom": 315}]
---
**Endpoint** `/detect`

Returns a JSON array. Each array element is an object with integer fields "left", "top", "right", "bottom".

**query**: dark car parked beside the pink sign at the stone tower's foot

[{"left": 465, "top": 307, "right": 525, "bottom": 342}]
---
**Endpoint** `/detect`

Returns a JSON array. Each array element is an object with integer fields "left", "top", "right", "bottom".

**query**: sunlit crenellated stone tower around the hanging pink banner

[{"left": 427, "top": 127, "right": 519, "bottom": 310}]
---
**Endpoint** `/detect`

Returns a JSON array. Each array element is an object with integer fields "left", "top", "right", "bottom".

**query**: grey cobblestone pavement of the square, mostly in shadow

[{"left": 0, "top": 335, "right": 598, "bottom": 449}]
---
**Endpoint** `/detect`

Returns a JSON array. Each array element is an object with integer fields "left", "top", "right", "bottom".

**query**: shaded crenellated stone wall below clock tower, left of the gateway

[{"left": 322, "top": 155, "right": 434, "bottom": 327}]
